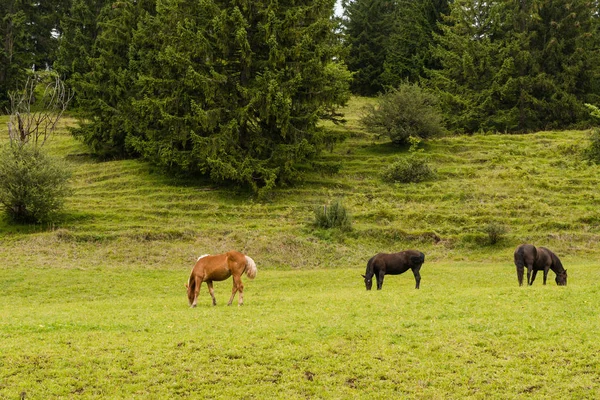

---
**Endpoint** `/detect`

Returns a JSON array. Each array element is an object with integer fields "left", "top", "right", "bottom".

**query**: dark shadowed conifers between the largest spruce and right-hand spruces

[{"left": 343, "top": 0, "right": 448, "bottom": 96}]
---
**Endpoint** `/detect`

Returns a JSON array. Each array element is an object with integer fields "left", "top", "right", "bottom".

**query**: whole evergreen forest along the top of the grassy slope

[{"left": 0, "top": 0, "right": 600, "bottom": 194}]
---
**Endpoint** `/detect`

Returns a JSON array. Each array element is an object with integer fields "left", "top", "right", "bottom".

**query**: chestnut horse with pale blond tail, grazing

[{"left": 185, "top": 251, "right": 256, "bottom": 307}]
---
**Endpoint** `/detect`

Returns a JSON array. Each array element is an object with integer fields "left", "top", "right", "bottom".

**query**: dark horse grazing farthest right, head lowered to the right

[{"left": 515, "top": 244, "right": 567, "bottom": 286}]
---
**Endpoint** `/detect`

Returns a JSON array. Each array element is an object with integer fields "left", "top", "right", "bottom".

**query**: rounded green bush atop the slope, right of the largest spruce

[{"left": 360, "top": 83, "right": 444, "bottom": 144}]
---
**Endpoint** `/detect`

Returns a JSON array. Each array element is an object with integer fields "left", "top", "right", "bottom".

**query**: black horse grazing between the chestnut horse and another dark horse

[{"left": 362, "top": 250, "right": 425, "bottom": 290}]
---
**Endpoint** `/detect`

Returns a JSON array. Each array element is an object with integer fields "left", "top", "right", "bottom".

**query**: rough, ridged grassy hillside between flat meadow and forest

[{"left": 0, "top": 98, "right": 600, "bottom": 269}]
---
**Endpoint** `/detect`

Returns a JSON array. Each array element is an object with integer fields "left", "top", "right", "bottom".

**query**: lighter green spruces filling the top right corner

[{"left": 430, "top": 0, "right": 600, "bottom": 132}]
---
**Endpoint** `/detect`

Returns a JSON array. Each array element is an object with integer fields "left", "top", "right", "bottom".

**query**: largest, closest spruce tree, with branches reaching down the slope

[{"left": 127, "top": 0, "right": 349, "bottom": 191}]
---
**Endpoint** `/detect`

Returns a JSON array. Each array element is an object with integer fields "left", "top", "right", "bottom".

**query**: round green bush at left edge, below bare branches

[{"left": 0, "top": 144, "right": 70, "bottom": 223}]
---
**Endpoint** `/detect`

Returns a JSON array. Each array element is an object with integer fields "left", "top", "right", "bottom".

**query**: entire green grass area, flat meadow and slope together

[{"left": 0, "top": 98, "right": 600, "bottom": 399}]
